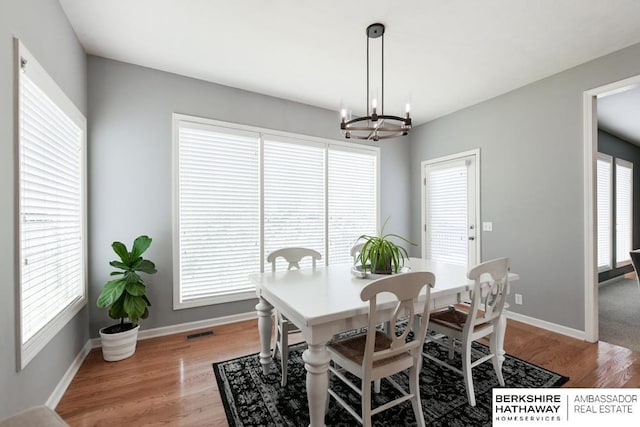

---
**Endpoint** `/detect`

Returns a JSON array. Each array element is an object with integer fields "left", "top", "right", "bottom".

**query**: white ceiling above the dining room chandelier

[{"left": 60, "top": 0, "right": 640, "bottom": 124}]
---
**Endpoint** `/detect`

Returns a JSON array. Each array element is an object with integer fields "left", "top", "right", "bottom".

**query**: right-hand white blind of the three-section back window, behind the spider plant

[{"left": 328, "top": 146, "right": 378, "bottom": 264}]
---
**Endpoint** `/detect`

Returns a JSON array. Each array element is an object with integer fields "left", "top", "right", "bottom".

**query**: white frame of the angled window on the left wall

[{"left": 14, "top": 38, "right": 88, "bottom": 370}]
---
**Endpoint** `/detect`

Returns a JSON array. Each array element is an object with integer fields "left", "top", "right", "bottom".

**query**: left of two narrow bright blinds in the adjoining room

[{"left": 596, "top": 153, "right": 612, "bottom": 271}]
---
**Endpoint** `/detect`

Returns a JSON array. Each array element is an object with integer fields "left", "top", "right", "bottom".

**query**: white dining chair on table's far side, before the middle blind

[{"left": 267, "top": 248, "right": 322, "bottom": 387}]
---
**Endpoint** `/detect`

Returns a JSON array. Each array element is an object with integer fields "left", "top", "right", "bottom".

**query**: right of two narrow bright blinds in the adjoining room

[{"left": 616, "top": 159, "right": 633, "bottom": 266}]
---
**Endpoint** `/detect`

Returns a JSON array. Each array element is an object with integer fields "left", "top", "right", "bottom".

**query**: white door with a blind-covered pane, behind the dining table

[{"left": 422, "top": 150, "right": 480, "bottom": 267}]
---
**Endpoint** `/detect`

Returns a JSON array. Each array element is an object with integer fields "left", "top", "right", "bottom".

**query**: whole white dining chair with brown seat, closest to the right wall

[{"left": 424, "top": 258, "right": 509, "bottom": 406}]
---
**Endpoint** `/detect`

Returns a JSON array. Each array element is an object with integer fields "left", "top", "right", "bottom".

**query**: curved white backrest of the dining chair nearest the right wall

[{"left": 463, "top": 258, "right": 509, "bottom": 333}]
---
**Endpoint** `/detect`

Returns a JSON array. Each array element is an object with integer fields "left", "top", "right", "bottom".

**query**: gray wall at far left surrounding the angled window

[{"left": 0, "top": 0, "right": 89, "bottom": 418}]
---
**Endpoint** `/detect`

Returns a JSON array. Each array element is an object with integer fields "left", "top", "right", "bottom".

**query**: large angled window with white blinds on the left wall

[{"left": 17, "top": 42, "right": 87, "bottom": 368}]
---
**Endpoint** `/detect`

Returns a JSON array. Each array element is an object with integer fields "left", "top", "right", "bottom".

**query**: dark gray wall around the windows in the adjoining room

[{"left": 598, "top": 129, "right": 640, "bottom": 282}]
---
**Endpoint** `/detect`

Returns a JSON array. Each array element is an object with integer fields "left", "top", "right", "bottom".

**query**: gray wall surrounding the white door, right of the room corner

[{"left": 411, "top": 44, "right": 640, "bottom": 331}]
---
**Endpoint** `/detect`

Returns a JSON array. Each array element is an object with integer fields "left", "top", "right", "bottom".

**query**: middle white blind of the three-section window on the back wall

[{"left": 264, "top": 135, "right": 325, "bottom": 269}]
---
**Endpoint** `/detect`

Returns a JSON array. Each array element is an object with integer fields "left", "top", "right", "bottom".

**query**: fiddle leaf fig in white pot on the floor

[{"left": 97, "top": 236, "right": 157, "bottom": 361}]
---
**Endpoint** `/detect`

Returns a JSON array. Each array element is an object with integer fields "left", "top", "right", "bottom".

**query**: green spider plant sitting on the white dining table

[{"left": 358, "top": 218, "right": 416, "bottom": 274}]
